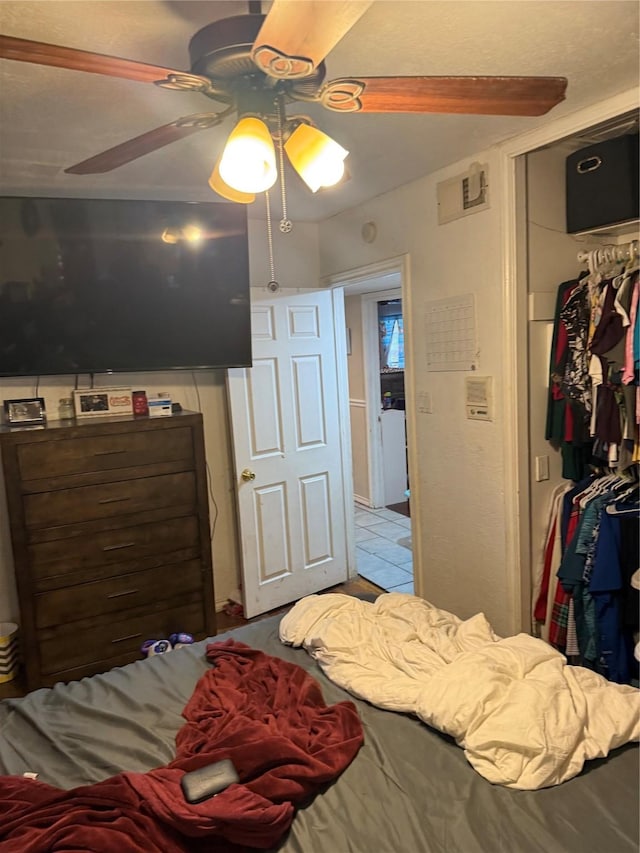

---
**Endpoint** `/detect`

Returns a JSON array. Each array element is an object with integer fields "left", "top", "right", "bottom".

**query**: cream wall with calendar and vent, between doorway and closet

[{"left": 320, "top": 150, "right": 519, "bottom": 633}]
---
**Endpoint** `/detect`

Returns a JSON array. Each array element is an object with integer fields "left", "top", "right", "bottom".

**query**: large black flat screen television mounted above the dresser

[{"left": 0, "top": 196, "right": 251, "bottom": 376}]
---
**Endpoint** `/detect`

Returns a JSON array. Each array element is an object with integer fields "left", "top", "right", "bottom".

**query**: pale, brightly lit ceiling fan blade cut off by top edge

[{"left": 251, "top": 0, "right": 372, "bottom": 79}]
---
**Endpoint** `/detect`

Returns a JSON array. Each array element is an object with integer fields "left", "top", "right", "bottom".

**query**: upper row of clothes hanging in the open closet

[{"left": 545, "top": 250, "right": 640, "bottom": 481}]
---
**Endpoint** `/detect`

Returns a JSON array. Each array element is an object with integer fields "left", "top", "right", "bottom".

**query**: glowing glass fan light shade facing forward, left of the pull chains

[{"left": 219, "top": 117, "right": 278, "bottom": 193}]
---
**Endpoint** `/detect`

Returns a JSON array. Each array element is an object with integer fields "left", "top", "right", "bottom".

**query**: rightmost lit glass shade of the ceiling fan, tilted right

[{"left": 284, "top": 124, "right": 349, "bottom": 193}]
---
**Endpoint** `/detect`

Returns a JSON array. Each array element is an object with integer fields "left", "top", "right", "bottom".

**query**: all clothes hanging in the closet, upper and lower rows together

[{"left": 544, "top": 241, "right": 640, "bottom": 683}]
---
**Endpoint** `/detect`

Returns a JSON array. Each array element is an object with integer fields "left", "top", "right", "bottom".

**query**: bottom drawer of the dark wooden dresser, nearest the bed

[{"left": 38, "top": 602, "right": 206, "bottom": 683}]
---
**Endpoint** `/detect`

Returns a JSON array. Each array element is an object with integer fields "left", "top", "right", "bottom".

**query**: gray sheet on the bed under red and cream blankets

[{"left": 0, "top": 616, "right": 640, "bottom": 853}]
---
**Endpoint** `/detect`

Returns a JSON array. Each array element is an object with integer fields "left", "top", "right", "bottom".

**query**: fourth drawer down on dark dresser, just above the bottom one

[{"left": 35, "top": 560, "right": 202, "bottom": 628}]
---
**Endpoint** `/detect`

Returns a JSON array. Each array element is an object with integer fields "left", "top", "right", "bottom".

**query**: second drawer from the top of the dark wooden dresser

[{"left": 24, "top": 471, "right": 196, "bottom": 528}]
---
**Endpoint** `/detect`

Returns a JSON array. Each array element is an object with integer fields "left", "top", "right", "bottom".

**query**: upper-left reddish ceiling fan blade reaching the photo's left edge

[{"left": 0, "top": 34, "right": 190, "bottom": 83}]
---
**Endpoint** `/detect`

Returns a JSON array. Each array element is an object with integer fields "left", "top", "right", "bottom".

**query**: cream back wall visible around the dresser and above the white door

[{"left": 0, "top": 220, "right": 319, "bottom": 621}]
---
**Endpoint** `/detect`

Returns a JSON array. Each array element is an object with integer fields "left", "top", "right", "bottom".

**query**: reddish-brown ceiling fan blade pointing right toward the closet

[{"left": 319, "top": 77, "right": 567, "bottom": 116}]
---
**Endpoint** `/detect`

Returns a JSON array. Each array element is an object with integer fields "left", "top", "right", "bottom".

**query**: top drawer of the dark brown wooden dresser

[{"left": 18, "top": 427, "right": 193, "bottom": 480}]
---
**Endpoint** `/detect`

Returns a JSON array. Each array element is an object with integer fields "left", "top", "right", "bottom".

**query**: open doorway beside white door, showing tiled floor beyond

[{"left": 332, "top": 266, "right": 414, "bottom": 593}]
